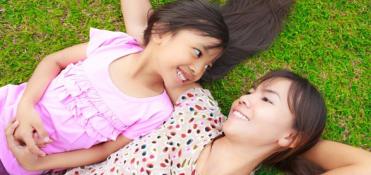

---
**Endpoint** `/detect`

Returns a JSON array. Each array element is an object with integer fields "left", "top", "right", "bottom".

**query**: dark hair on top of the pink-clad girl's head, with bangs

[{"left": 144, "top": 0, "right": 229, "bottom": 49}]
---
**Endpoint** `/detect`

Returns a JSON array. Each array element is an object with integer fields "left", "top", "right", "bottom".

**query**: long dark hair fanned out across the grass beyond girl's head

[{"left": 201, "top": 0, "right": 294, "bottom": 81}]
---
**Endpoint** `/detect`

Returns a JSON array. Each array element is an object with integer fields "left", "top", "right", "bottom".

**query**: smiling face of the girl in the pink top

[{"left": 153, "top": 30, "right": 222, "bottom": 88}]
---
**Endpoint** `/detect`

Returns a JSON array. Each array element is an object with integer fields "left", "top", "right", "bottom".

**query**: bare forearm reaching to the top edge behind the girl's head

[{"left": 121, "top": 0, "right": 152, "bottom": 44}]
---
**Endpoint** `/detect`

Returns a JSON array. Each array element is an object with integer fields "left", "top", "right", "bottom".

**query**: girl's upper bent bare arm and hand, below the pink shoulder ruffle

[{"left": 15, "top": 44, "right": 87, "bottom": 155}]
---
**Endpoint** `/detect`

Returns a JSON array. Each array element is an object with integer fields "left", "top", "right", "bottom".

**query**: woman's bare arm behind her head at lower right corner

[{"left": 304, "top": 140, "right": 371, "bottom": 175}]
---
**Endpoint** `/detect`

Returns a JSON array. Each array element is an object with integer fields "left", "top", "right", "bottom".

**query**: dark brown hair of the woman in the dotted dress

[{"left": 258, "top": 70, "right": 326, "bottom": 175}]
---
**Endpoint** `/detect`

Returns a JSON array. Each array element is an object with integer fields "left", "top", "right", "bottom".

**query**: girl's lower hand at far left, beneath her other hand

[{"left": 5, "top": 121, "right": 40, "bottom": 171}]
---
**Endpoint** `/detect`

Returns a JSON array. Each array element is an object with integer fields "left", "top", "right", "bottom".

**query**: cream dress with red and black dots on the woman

[{"left": 66, "top": 88, "right": 225, "bottom": 175}]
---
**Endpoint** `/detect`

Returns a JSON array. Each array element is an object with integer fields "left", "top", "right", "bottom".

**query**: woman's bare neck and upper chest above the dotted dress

[{"left": 201, "top": 137, "right": 275, "bottom": 175}]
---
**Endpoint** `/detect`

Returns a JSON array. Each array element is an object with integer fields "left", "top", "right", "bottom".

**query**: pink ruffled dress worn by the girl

[{"left": 0, "top": 29, "right": 173, "bottom": 175}]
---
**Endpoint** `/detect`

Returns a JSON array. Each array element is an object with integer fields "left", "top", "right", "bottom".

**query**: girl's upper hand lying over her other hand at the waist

[{"left": 14, "top": 102, "right": 51, "bottom": 156}]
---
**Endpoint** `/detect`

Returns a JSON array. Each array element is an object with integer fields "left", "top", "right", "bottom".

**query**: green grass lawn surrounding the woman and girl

[{"left": 0, "top": 0, "right": 371, "bottom": 174}]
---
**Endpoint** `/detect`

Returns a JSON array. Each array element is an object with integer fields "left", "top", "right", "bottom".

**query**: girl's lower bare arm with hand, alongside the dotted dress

[{"left": 6, "top": 121, "right": 131, "bottom": 171}]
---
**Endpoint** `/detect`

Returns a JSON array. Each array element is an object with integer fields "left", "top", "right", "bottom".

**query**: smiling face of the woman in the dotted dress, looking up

[{"left": 223, "top": 78, "right": 295, "bottom": 147}]
